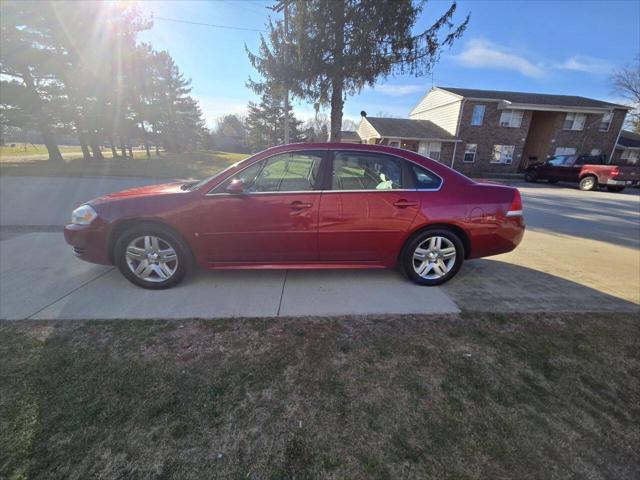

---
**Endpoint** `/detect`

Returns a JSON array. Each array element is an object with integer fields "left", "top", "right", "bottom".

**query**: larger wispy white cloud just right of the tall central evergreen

[{"left": 456, "top": 39, "right": 544, "bottom": 77}]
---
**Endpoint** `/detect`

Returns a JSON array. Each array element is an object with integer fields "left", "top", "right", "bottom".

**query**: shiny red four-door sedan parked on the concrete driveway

[{"left": 64, "top": 143, "right": 524, "bottom": 289}]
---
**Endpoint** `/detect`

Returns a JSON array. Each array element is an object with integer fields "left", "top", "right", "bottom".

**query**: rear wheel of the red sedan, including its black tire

[{"left": 400, "top": 228, "right": 465, "bottom": 286}]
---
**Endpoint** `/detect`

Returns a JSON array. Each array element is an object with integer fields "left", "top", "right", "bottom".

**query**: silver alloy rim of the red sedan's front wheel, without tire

[{"left": 125, "top": 235, "right": 178, "bottom": 283}]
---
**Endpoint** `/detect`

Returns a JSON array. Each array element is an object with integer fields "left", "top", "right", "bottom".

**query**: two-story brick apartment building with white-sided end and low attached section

[{"left": 357, "top": 87, "right": 630, "bottom": 174}]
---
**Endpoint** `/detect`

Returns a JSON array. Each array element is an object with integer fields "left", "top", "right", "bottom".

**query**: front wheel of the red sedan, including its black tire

[{"left": 114, "top": 224, "right": 192, "bottom": 290}]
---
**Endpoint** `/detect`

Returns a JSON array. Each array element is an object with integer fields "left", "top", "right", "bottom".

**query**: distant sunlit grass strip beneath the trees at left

[{"left": 0, "top": 150, "right": 248, "bottom": 178}]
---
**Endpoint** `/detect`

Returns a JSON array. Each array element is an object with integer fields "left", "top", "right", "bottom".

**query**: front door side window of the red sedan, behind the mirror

[{"left": 214, "top": 152, "right": 322, "bottom": 193}]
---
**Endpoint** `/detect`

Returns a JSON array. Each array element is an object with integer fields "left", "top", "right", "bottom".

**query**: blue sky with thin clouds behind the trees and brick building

[{"left": 138, "top": 0, "right": 640, "bottom": 126}]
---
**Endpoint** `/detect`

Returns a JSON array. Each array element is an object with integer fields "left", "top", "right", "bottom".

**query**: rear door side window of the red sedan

[{"left": 331, "top": 151, "right": 402, "bottom": 190}]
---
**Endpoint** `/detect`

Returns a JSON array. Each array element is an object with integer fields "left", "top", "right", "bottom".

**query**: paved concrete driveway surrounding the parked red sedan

[{"left": 0, "top": 177, "right": 640, "bottom": 319}]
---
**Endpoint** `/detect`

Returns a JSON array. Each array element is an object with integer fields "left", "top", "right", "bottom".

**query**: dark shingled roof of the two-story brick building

[{"left": 438, "top": 87, "right": 629, "bottom": 108}]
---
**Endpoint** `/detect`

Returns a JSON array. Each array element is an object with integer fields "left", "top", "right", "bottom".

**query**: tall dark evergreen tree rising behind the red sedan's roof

[{"left": 247, "top": 0, "right": 469, "bottom": 141}]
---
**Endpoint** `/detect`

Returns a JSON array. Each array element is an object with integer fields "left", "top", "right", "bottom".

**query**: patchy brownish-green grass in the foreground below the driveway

[{"left": 0, "top": 314, "right": 640, "bottom": 480}]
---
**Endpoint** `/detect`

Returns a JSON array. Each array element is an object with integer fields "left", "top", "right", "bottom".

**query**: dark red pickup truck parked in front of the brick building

[{"left": 524, "top": 155, "right": 640, "bottom": 192}]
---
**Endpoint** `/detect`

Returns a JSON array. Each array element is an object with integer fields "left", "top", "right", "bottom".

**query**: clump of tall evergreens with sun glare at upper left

[{"left": 0, "top": 1, "right": 205, "bottom": 161}]
